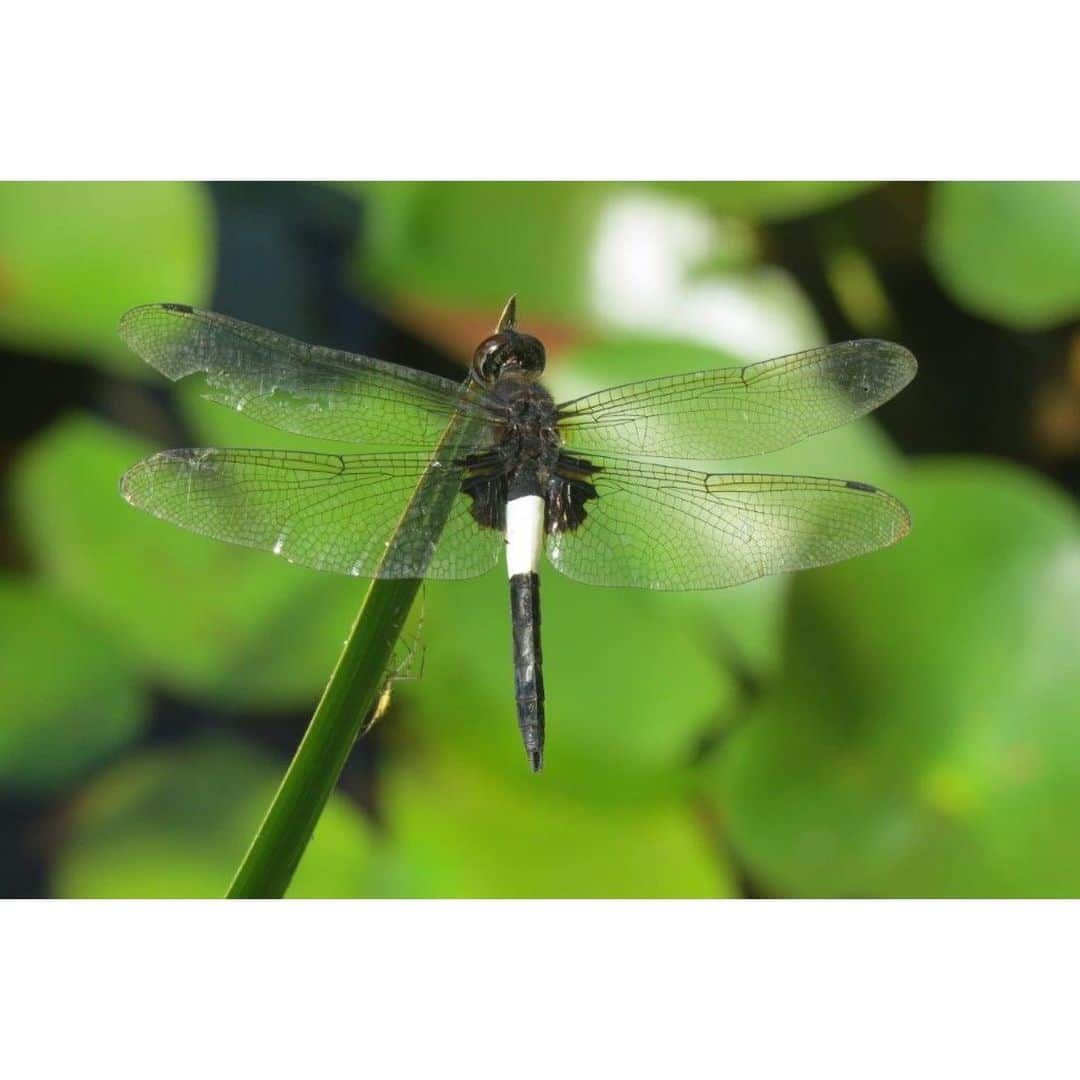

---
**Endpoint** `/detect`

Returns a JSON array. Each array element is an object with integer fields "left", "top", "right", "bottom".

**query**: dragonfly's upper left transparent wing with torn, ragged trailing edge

[{"left": 120, "top": 303, "right": 490, "bottom": 447}]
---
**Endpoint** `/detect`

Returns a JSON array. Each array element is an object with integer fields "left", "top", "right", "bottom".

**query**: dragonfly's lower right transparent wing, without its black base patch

[{"left": 548, "top": 459, "right": 910, "bottom": 590}]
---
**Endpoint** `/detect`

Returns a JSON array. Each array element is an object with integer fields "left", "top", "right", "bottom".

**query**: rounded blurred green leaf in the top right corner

[{"left": 927, "top": 183, "right": 1080, "bottom": 329}]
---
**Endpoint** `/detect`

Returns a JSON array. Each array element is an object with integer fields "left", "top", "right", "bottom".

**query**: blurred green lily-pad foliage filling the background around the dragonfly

[{"left": 0, "top": 183, "right": 1080, "bottom": 896}]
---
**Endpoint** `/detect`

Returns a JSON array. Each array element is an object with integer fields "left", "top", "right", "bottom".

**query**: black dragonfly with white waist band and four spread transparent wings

[{"left": 120, "top": 297, "right": 916, "bottom": 772}]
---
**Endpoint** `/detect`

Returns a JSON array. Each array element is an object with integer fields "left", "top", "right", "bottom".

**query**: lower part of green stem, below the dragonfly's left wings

[{"left": 227, "top": 579, "right": 420, "bottom": 899}]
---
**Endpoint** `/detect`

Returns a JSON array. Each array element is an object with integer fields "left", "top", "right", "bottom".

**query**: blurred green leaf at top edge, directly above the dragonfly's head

[{"left": 362, "top": 183, "right": 609, "bottom": 319}]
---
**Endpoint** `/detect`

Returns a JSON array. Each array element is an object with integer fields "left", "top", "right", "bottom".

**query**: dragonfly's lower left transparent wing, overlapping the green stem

[{"left": 121, "top": 449, "right": 503, "bottom": 579}]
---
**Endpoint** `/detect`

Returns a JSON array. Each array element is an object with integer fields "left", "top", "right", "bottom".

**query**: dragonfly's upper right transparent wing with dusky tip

[{"left": 558, "top": 340, "right": 916, "bottom": 460}]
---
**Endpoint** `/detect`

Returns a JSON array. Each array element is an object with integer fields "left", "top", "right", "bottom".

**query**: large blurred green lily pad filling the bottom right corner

[{"left": 711, "top": 460, "right": 1080, "bottom": 896}]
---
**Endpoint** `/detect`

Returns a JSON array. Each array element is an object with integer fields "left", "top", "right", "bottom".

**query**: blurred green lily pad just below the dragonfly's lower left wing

[{"left": 13, "top": 417, "right": 363, "bottom": 708}]
